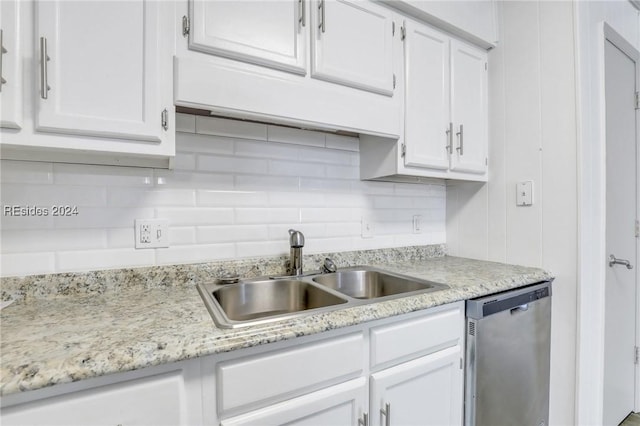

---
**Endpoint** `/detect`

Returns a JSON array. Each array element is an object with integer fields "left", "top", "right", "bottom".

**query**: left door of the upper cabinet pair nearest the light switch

[{"left": 404, "top": 21, "right": 449, "bottom": 170}]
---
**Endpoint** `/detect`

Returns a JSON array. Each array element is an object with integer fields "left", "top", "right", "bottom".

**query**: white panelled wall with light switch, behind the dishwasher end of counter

[{"left": 447, "top": 1, "right": 578, "bottom": 425}]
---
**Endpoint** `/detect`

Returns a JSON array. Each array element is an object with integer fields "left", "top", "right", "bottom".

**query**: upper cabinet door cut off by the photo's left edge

[{"left": 0, "top": 0, "right": 22, "bottom": 129}]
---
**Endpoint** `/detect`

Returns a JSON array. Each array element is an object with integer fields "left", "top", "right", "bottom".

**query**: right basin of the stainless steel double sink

[{"left": 313, "top": 267, "right": 448, "bottom": 299}]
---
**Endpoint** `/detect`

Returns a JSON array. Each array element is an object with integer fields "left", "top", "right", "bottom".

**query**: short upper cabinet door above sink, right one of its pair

[{"left": 311, "top": 0, "right": 394, "bottom": 96}]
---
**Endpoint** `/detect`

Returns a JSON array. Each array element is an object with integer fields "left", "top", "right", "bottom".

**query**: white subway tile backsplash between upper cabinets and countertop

[{"left": 0, "top": 114, "right": 446, "bottom": 276}]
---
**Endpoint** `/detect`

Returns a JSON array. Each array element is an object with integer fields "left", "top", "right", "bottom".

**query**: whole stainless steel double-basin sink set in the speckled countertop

[{"left": 197, "top": 266, "right": 449, "bottom": 328}]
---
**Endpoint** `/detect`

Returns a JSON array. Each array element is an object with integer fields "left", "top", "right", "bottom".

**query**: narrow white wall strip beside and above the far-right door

[{"left": 575, "top": 0, "right": 640, "bottom": 425}]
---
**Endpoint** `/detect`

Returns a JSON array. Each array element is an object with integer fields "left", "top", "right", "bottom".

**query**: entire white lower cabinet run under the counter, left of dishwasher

[{"left": 0, "top": 302, "right": 464, "bottom": 426}]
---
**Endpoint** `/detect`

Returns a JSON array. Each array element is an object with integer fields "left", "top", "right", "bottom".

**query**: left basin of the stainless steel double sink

[{"left": 198, "top": 279, "right": 347, "bottom": 328}]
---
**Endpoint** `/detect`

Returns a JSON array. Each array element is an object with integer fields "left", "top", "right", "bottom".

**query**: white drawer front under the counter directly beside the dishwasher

[{"left": 371, "top": 304, "right": 464, "bottom": 368}]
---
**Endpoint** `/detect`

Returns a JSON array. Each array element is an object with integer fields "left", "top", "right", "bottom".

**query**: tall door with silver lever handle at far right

[{"left": 603, "top": 30, "right": 639, "bottom": 425}]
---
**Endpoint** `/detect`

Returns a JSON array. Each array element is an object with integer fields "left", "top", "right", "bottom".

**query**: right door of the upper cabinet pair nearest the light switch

[{"left": 451, "top": 40, "right": 489, "bottom": 173}]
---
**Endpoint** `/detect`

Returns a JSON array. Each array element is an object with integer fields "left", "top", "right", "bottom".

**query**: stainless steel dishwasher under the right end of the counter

[{"left": 465, "top": 281, "right": 551, "bottom": 426}]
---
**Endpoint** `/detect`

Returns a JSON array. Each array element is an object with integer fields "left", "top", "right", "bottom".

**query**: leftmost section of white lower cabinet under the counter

[{"left": 1, "top": 361, "right": 202, "bottom": 426}]
